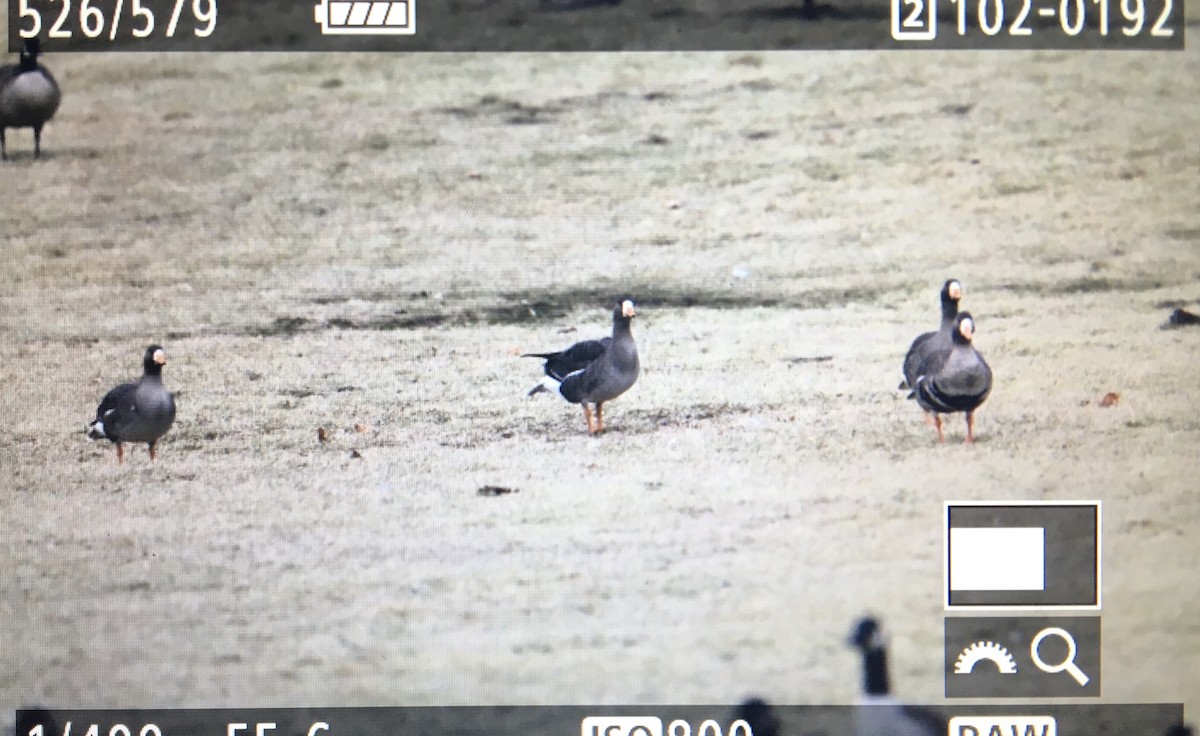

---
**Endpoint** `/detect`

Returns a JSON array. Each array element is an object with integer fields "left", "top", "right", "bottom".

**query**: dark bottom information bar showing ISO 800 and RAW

[{"left": 14, "top": 701, "right": 1183, "bottom": 736}]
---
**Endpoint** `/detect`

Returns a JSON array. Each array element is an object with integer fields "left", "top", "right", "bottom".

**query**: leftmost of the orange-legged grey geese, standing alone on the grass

[{"left": 88, "top": 345, "right": 175, "bottom": 462}]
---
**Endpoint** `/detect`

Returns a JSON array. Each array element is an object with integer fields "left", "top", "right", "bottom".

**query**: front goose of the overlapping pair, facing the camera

[{"left": 913, "top": 312, "right": 991, "bottom": 442}]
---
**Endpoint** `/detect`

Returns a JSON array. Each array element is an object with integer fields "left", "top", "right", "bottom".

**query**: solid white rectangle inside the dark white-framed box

[{"left": 950, "top": 527, "right": 1045, "bottom": 591}]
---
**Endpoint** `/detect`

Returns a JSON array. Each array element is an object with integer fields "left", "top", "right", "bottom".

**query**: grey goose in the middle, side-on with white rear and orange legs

[{"left": 524, "top": 299, "right": 640, "bottom": 435}]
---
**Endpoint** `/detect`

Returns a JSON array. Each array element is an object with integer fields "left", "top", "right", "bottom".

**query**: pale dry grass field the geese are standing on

[{"left": 0, "top": 8, "right": 1200, "bottom": 725}]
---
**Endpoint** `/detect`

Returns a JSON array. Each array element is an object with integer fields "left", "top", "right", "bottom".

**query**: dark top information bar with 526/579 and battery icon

[{"left": 7, "top": 0, "right": 1186, "bottom": 53}]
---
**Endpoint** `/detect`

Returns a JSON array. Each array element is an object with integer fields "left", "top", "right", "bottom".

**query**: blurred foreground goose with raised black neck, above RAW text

[{"left": 850, "top": 617, "right": 948, "bottom": 736}]
